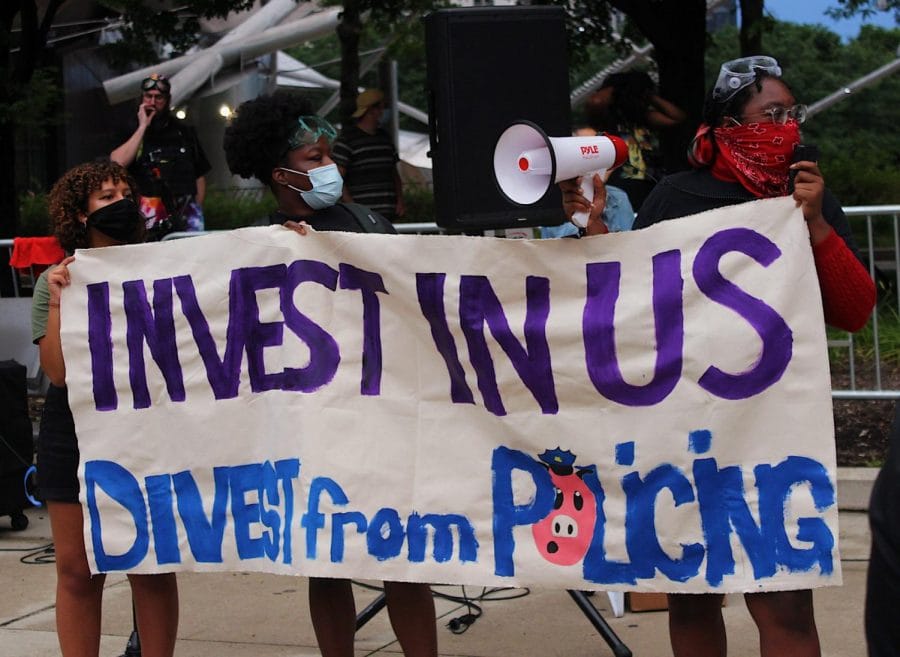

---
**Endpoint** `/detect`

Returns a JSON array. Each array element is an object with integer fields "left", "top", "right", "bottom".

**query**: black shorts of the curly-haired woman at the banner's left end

[{"left": 37, "top": 385, "right": 79, "bottom": 504}]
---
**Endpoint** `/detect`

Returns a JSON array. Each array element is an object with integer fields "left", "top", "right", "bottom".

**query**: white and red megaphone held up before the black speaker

[{"left": 494, "top": 121, "right": 628, "bottom": 228}]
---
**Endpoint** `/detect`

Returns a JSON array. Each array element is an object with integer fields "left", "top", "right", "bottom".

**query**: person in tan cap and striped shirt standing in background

[{"left": 331, "top": 89, "right": 405, "bottom": 221}]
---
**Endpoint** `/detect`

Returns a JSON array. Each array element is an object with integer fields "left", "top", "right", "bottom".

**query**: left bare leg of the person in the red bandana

[{"left": 669, "top": 593, "right": 724, "bottom": 657}]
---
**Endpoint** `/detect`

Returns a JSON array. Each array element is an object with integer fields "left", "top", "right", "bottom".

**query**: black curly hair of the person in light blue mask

[{"left": 223, "top": 90, "right": 313, "bottom": 186}]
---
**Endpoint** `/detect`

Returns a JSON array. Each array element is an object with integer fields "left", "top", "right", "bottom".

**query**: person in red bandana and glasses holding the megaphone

[{"left": 560, "top": 56, "right": 875, "bottom": 657}]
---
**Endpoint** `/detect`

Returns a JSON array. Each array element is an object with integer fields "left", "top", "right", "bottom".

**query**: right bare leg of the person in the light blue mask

[{"left": 384, "top": 582, "right": 437, "bottom": 657}]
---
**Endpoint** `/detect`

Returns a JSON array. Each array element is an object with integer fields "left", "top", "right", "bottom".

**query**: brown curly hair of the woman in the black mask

[{"left": 47, "top": 160, "right": 137, "bottom": 253}]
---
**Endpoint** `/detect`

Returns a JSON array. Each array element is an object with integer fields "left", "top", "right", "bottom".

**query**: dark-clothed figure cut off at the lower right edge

[{"left": 865, "top": 404, "right": 900, "bottom": 657}]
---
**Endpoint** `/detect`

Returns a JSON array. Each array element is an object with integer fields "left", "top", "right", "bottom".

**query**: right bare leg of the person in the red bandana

[{"left": 744, "top": 590, "right": 822, "bottom": 657}]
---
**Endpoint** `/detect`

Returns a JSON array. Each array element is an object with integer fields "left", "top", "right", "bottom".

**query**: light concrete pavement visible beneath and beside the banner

[{"left": 0, "top": 492, "right": 870, "bottom": 657}]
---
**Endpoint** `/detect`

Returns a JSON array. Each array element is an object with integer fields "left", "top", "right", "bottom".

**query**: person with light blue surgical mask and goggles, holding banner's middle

[{"left": 224, "top": 92, "right": 437, "bottom": 657}]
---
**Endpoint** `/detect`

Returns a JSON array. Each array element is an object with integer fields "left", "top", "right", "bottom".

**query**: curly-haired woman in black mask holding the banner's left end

[{"left": 31, "top": 161, "right": 178, "bottom": 657}]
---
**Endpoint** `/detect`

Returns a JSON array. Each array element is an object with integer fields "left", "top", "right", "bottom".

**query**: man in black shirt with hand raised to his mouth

[{"left": 110, "top": 73, "right": 212, "bottom": 239}]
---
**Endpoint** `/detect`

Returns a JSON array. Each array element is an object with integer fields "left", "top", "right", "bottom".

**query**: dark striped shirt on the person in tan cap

[{"left": 331, "top": 126, "right": 399, "bottom": 220}]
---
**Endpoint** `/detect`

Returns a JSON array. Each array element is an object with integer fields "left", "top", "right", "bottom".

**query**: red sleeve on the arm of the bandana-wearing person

[{"left": 813, "top": 231, "right": 876, "bottom": 332}]
